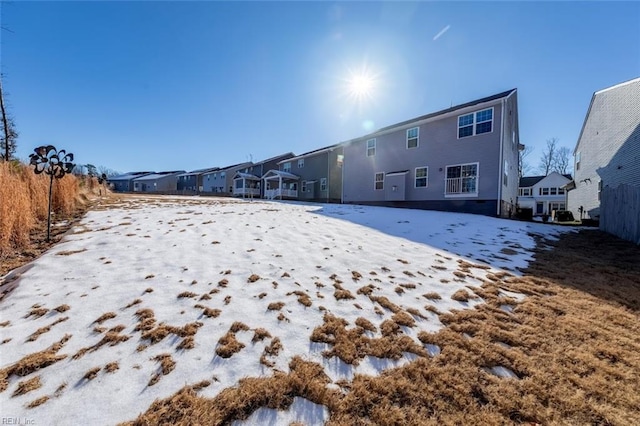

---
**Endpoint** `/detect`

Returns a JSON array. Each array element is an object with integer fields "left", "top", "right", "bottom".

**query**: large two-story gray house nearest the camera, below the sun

[{"left": 342, "top": 89, "right": 522, "bottom": 217}]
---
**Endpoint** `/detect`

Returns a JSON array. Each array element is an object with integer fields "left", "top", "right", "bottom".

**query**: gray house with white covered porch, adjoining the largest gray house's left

[{"left": 262, "top": 144, "right": 343, "bottom": 203}]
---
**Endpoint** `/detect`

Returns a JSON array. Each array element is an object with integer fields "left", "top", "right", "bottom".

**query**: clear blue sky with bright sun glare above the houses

[{"left": 0, "top": 1, "right": 640, "bottom": 172}]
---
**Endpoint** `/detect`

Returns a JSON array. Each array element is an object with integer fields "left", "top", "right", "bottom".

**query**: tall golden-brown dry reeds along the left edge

[{"left": 0, "top": 162, "right": 84, "bottom": 255}]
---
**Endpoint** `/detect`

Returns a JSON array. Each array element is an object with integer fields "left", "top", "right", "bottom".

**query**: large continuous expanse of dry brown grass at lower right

[{"left": 105, "top": 231, "right": 640, "bottom": 426}]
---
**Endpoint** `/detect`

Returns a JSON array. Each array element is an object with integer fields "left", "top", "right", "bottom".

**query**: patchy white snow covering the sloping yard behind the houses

[{"left": 0, "top": 197, "right": 570, "bottom": 425}]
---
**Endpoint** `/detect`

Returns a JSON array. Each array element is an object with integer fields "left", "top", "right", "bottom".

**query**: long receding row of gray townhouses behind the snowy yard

[{"left": 109, "top": 89, "right": 523, "bottom": 216}]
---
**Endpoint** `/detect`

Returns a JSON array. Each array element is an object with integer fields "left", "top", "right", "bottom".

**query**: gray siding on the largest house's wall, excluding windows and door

[{"left": 343, "top": 99, "right": 508, "bottom": 215}]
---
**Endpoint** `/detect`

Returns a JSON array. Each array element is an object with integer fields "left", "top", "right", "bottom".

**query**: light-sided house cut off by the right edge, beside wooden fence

[{"left": 567, "top": 78, "right": 640, "bottom": 226}]
